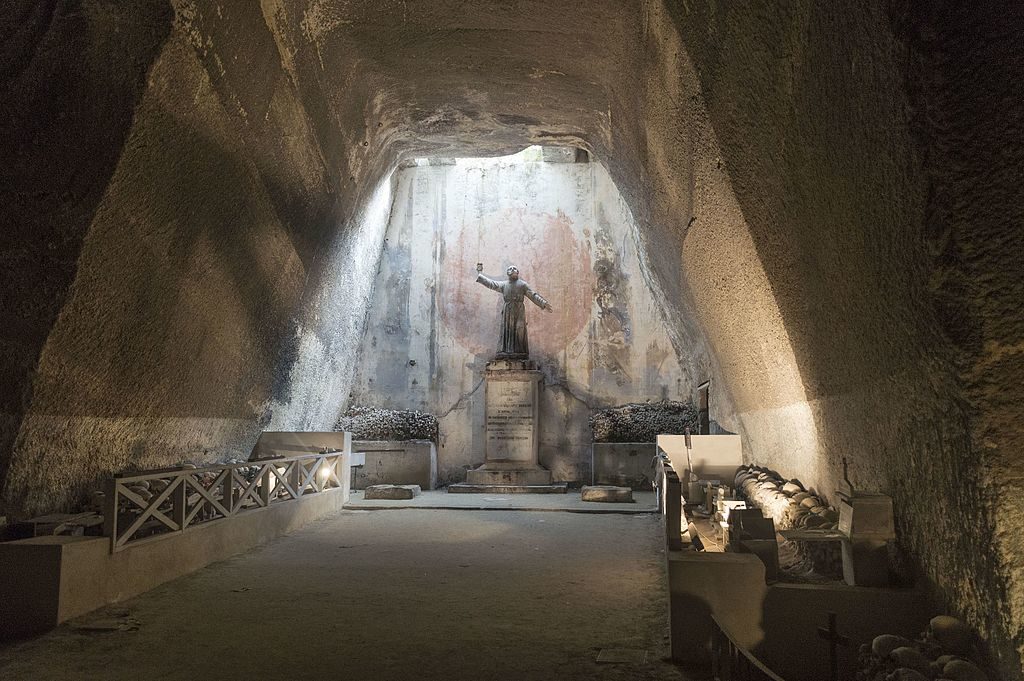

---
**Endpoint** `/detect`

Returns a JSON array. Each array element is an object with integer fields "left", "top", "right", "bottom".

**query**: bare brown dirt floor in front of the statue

[{"left": 0, "top": 509, "right": 684, "bottom": 681}]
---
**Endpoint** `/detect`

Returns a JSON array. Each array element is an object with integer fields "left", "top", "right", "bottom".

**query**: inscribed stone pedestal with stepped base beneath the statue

[{"left": 449, "top": 359, "right": 564, "bottom": 494}]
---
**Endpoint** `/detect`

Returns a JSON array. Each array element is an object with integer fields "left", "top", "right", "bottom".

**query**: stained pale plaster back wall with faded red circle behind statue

[{"left": 351, "top": 155, "right": 692, "bottom": 481}]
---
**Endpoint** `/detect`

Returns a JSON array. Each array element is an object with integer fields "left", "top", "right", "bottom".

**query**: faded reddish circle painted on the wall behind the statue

[{"left": 438, "top": 208, "right": 594, "bottom": 356}]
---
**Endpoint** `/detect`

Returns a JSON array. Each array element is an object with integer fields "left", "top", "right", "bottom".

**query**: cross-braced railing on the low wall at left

[{"left": 104, "top": 452, "right": 342, "bottom": 552}]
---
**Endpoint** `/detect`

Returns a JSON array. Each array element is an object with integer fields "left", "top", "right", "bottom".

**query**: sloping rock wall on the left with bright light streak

[{"left": 0, "top": 2, "right": 390, "bottom": 513}]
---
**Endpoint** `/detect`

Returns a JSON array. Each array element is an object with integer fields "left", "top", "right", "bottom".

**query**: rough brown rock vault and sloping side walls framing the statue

[{"left": 0, "top": 0, "right": 1024, "bottom": 678}]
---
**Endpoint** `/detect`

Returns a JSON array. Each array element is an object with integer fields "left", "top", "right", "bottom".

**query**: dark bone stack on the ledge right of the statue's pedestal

[{"left": 590, "top": 399, "right": 697, "bottom": 442}]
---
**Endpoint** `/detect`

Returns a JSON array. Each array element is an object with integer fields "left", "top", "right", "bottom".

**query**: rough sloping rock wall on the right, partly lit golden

[{"left": 613, "top": 2, "right": 1024, "bottom": 678}]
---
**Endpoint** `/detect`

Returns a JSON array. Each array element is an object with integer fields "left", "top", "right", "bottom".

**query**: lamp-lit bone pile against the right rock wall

[{"left": 734, "top": 466, "right": 843, "bottom": 579}]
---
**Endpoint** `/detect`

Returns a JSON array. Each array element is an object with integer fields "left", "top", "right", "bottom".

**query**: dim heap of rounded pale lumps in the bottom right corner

[{"left": 857, "top": 614, "right": 988, "bottom": 681}]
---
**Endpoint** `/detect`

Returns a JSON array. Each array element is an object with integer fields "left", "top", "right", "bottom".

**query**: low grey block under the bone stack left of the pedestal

[{"left": 352, "top": 440, "right": 437, "bottom": 490}]
